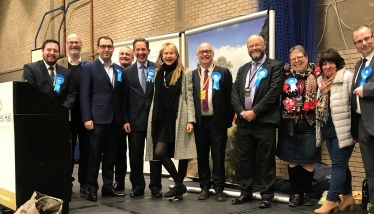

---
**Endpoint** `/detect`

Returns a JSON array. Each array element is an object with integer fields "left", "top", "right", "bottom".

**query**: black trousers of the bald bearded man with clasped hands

[{"left": 237, "top": 121, "right": 276, "bottom": 200}]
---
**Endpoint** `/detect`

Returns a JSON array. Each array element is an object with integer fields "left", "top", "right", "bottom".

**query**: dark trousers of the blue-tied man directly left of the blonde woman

[{"left": 128, "top": 130, "right": 162, "bottom": 191}]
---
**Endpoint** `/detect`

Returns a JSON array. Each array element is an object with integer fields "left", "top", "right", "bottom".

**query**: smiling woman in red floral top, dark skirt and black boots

[{"left": 277, "top": 45, "right": 321, "bottom": 207}]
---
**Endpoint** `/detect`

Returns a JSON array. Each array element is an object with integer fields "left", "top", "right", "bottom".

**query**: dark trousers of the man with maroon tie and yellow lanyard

[{"left": 195, "top": 116, "right": 227, "bottom": 190}]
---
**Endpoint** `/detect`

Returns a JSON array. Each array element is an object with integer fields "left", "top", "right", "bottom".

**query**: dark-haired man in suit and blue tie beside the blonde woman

[{"left": 123, "top": 38, "right": 163, "bottom": 198}]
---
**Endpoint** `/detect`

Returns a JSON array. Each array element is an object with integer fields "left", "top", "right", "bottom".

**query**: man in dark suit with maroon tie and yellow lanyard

[{"left": 192, "top": 43, "right": 234, "bottom": 201}]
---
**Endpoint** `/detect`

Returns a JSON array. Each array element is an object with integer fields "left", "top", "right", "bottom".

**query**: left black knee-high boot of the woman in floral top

[{"left": 288, "top": 165, "right": 304, "bottom": 207}]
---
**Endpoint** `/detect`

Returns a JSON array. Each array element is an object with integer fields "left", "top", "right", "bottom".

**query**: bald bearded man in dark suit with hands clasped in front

[{"left": 231, "top": 35, "right": 284, "bottom": 208}]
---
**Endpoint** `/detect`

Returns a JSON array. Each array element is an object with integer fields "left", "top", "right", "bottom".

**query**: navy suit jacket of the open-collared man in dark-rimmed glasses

[{"left": 80, "top": 59, "right": 124, "bottom": 126}]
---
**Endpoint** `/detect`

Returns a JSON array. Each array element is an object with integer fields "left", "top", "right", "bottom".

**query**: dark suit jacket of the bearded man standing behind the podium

[{"left": 22, "top": 60, "right": 77, "bottom": 109}]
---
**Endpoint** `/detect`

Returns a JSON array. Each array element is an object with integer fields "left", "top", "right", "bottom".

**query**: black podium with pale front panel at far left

[{"left": 0, "top": 81, "right": 72, "bottom": 213}]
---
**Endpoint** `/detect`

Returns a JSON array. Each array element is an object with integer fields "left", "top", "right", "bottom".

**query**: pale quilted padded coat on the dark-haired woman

[{"left": 316, "top": 68, "right": 354, "bottom": 148}]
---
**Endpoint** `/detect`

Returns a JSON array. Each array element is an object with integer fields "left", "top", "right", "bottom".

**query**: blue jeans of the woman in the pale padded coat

[{"left": 326, "top": 137, "right": 354, "bottom": 202}]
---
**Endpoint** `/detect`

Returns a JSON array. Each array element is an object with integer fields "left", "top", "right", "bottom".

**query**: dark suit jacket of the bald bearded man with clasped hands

[{"left": 231, "top": 57, "right": 285, "bottom": 127}]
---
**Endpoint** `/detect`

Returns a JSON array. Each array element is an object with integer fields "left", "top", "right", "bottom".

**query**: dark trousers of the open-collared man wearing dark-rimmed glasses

[{"left": 87, "top": 119, "right": 122, "bottom": 192}]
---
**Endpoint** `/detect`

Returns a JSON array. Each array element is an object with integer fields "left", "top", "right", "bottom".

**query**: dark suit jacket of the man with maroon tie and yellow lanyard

[{"left": 192, "top": 66, "right": 234, "bottom": 129}]
